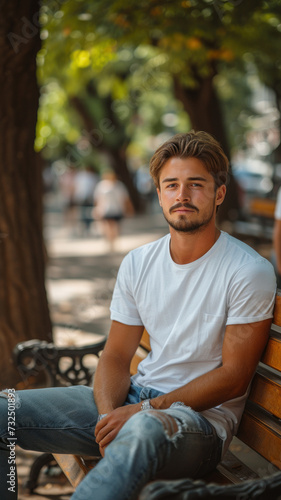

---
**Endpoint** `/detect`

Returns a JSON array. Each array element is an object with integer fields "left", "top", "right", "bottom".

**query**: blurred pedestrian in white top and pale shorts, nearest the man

[{"left": 94, "top": 171, "right": 133, "bottom": 250}]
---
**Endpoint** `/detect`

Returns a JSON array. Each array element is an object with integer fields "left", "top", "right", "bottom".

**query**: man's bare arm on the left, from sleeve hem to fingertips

[{"left": 94, "top": 321, "right": 143, "bottom": 455}]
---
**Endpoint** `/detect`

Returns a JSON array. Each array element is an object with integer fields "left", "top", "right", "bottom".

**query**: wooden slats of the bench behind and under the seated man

[{"left": 51, "top": 290, "right": 281, "bottom": 498}]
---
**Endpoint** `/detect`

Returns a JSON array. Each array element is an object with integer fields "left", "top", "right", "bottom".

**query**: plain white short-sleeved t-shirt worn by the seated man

[{"left": 110, "top": 232, "right": 276, "bottom": 451}]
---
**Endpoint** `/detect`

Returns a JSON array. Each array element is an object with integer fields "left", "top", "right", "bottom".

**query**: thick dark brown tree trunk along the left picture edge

[{"left": 0, "top": 0, "right": 51, "bottom": 388}]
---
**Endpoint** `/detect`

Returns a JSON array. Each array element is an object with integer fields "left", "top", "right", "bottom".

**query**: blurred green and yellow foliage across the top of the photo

[{"left": 36, "top": 0, "right": 281, "bottom": 163}]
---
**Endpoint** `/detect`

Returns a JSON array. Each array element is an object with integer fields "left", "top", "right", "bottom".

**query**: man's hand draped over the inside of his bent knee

[{"left": 95, "top": 403, "right": 141, "bottom": 457}]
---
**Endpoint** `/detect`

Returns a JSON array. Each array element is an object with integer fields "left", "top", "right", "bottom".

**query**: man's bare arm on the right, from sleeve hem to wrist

[{"left": 151, "top": 319, "right": 271, "bottom": 411}]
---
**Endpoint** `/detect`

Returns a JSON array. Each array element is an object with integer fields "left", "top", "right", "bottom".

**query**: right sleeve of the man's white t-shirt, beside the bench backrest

[{"left": 226, "top": 258, "right": 276, "bottom": 325}]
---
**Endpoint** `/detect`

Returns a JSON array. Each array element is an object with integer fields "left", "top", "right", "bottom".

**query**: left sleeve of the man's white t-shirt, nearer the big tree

[{"left": 110, "top": 254, "right": 143, "bottom": 326}]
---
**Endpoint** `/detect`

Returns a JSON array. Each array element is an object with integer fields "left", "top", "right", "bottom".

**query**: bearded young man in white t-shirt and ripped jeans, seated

[{"left": 0, "top": 132, "right": 275, "bottom": 500}]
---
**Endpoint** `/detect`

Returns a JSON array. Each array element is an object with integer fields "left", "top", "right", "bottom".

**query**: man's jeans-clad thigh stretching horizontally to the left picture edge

[{"left": 0, "top": 386, "right": 98, "bottom": 455}]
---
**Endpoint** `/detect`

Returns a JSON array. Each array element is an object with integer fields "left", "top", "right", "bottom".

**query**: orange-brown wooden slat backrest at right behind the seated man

[{"left": 237, "top": 290, "right": 281, "bottom": 469}]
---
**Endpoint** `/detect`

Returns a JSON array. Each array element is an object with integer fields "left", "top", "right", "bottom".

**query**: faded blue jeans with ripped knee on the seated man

[{"left": 0, "top": 385, "right": 222, "bottom": 500}]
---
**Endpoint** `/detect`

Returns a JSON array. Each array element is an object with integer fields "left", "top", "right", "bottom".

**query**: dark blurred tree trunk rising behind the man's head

[{"left": 174, "top": 73, "right": 239, "bottom": 222}]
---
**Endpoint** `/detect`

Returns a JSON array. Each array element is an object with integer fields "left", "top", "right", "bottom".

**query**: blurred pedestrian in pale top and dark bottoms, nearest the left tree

[{"left": 74, "top": 166, "right": 99, "bottom": 233}]
